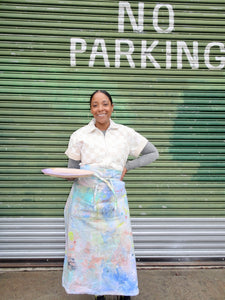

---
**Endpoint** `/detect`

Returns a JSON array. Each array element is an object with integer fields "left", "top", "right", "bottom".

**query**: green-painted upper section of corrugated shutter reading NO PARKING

[{"left": 0, "top": 0, "right": 225, "bottom": 258}]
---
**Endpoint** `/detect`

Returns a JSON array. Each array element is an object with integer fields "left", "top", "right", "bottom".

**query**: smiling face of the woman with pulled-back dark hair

[{"left": 91, "top": 92, "right": 113, "bottom": 130}]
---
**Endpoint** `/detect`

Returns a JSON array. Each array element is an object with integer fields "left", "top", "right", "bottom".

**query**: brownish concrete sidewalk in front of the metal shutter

[{"left": 0, "top": 267, "right": 225, "bottom": 300}]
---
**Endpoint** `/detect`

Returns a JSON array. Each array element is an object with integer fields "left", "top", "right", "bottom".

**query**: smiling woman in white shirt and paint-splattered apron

[{"left": 63, "top": 90, "right": 158, "bottom": 300}]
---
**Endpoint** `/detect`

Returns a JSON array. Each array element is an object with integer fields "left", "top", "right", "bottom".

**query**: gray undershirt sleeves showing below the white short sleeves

[{"left": 68, "top": 142, "right": 159, "bottom": 171}]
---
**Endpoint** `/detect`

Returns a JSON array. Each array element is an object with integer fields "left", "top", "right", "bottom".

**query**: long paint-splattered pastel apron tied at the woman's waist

[{"left": 63, "top": 165, "right": 139, "bottom": 296}]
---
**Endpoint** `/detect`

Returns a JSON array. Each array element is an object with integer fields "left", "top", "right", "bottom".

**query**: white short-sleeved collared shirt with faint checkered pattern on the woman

[{"left": 65, "top": 119, "right": 148, "bottom": 171}]
